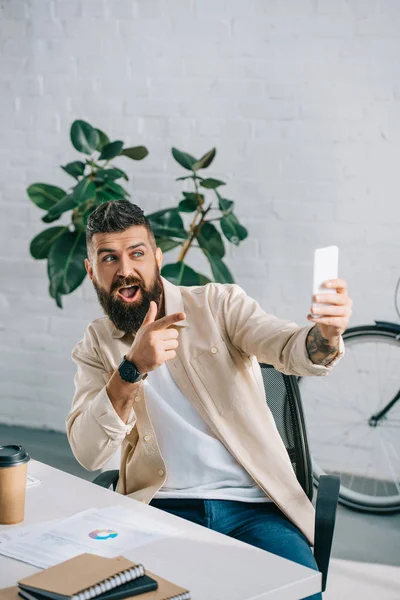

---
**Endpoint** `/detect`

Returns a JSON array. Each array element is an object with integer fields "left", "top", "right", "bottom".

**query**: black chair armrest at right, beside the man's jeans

[{"left": 314, "top": 475, "right": 340, "bottom": 592}]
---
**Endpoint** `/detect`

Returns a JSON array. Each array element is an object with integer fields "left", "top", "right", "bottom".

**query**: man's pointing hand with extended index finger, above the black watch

[{"left": 126, "top": 301, "right": 186, "bottom": 374}]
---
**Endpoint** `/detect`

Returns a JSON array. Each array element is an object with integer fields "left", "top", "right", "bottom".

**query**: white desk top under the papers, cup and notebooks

[{"left": 0, "top": 461, "right": 321, "bottom": 600}]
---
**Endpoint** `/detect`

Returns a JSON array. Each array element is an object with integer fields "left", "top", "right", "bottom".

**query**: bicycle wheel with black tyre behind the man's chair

[{"left": 299, "top": 324, "right": 400, "bottom": 513}]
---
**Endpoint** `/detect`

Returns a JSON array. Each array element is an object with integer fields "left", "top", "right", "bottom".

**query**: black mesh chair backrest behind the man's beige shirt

[{"left": 260, "top": 363, "right": 313, "bottom": 500}]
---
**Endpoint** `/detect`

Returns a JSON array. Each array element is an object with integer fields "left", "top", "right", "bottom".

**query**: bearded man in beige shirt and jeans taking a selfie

[{"left": 67, "top": 200, "right": 352, "bottom": 600}]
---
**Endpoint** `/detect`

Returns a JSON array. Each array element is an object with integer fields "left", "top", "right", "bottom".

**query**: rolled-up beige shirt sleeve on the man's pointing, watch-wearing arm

[{"left": 66, "top": 333, "right": 136, "bottom": 471}]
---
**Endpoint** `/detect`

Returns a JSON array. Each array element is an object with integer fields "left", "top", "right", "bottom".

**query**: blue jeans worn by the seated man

[{"left": 150, "top": 498, "right": 322, "bottom": 600}]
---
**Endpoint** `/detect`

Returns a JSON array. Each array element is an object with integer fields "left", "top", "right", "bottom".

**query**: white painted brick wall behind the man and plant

[{"left": 0, "top": 0, "right": 400, "bottom": 430}]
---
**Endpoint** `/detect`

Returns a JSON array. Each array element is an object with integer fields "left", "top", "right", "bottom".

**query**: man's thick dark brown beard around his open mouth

[{"left": 93, "top": 267, "right": 163, "bottom": 334}]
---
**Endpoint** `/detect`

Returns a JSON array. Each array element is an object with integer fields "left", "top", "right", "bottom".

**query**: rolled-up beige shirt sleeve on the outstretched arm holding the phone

[{"left": 220, "top": 284, "right": 344, "bottom": 376}]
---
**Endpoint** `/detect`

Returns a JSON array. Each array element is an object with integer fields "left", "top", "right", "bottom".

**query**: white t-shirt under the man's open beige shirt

[{"left": 144, "top": 363, "right": 270, "bottom": 502}]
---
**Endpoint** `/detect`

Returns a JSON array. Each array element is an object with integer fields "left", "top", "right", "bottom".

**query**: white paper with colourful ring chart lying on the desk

[{"left": 0, "top": 506, "right": 179, "bottom": 569}]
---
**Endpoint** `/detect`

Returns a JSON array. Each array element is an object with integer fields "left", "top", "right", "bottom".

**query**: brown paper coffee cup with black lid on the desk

[{"left": 0, "top": 445, "right": 29, "bottom": 525}]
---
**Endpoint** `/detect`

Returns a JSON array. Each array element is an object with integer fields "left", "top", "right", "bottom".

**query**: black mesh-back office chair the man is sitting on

[{"left": 93, "top": 364, "right": 340, "bottom": 591}]
